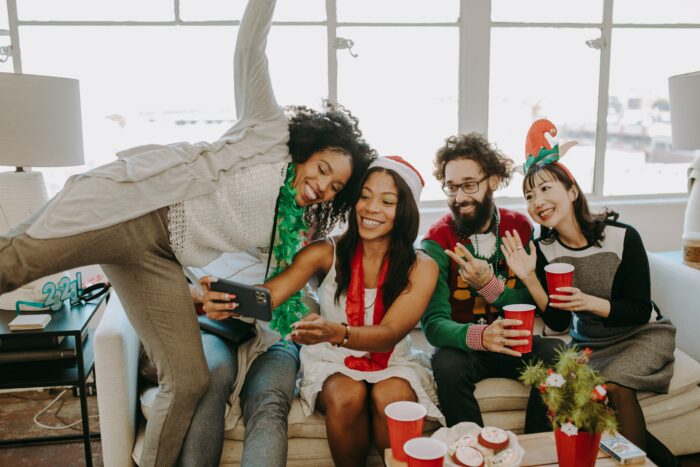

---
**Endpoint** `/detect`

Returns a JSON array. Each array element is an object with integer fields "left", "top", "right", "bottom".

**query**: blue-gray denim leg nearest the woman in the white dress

[{"left": 241, "top": 341, "right": 299, "bottom": 467}]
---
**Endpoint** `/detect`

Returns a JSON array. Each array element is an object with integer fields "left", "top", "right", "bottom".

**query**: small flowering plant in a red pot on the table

[{"left": 520, "top": 347, "right": 617, "bottom": 467}]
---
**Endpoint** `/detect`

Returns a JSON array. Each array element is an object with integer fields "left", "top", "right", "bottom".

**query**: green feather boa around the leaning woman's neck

[{"left": 267, "top": 164, "right": 309, "bottom": 337}]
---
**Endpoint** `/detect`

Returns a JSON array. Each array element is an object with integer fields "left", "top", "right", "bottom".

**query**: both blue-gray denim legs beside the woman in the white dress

[{"left": 178, "top": 332, "right": 299, "bottom": 467}]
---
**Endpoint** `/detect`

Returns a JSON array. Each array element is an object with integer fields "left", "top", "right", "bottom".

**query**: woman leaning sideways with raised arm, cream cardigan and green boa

[{"left": 0, "top": 0, "right": 375, "bottom": 466}]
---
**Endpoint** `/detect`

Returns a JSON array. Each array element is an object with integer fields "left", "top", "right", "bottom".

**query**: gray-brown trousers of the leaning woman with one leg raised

[{"left": 0, "top": 207, "right": 209, "bottom": 467}]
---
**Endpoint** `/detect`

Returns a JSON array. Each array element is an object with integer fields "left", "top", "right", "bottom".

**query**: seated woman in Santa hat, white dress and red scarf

[{"left": 205, "top": 156, "right": 442, "bottom": 466}]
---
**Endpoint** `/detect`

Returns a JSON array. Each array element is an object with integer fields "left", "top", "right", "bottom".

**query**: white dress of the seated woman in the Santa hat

[{"left": 300, "top": 242, "right": 445, "bottom": 425}]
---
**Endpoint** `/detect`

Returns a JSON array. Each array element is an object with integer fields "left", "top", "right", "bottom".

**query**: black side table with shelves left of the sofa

[{"left": 0, "top": 294, "right": 109, "bottom": 467}]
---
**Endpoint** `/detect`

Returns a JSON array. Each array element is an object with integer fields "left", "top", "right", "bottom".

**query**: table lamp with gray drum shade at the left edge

[{"left": 0, "top": 73, "right": 84, "bottom": 234}]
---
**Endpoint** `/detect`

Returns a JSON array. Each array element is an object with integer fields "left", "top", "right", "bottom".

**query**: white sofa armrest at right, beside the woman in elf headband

[{"left": 649, "top": 253, "right": 700, "bottom": 361}]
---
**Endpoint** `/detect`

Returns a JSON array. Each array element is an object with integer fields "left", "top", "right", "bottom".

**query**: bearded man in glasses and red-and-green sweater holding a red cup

[{"left": 421, "top": 133, "right": 563, "bottom": 433}]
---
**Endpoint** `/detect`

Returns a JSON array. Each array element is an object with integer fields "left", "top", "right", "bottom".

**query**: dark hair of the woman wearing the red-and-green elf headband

[{"left": 523, "top": 163, "right": 619, "bottom": 246}]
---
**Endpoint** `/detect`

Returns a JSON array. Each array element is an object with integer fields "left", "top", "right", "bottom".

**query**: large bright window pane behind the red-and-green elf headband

[{"left": 489, "top": 28, "right": 600, "bottom": 197}]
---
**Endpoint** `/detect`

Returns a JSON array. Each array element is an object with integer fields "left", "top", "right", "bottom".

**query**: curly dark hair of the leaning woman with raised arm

[{"left": 285, "top": 100, "right": 377, "bottom": 239}]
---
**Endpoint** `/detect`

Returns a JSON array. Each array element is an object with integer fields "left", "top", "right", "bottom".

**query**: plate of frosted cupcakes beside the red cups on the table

[{"left": 432, "top": 422, "right": 525, "bottom": 467}]
